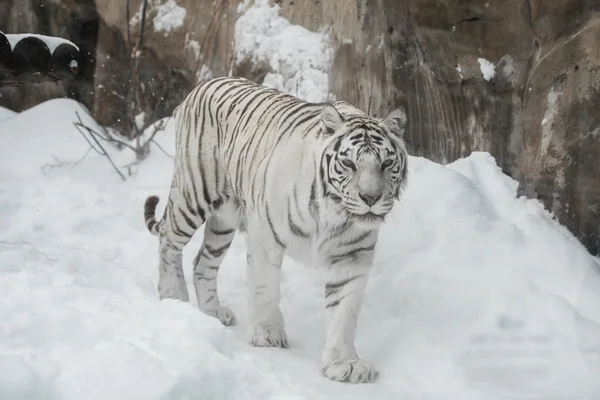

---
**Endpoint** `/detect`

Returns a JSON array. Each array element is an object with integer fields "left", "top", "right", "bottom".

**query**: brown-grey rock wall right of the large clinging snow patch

[{"left": 281, "top": 0, "right": 600, "bottom": 254}]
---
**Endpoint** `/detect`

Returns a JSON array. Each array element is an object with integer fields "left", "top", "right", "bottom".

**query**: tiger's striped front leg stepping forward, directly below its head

[{"left": 322, "top": 249, "right": 379, "bottom": 383}]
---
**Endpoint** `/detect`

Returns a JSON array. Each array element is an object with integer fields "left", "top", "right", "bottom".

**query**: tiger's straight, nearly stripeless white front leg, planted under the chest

[{"left": 246, "top": 214, "right": 288, "bottom": 348}]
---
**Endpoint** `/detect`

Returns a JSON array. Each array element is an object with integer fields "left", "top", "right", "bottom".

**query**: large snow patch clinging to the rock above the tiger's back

[{"left": 235, "top": 0, "right": 332, "bottom": 102}]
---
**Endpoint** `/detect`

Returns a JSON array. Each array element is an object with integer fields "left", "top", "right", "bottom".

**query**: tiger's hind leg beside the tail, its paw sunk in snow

[{"left": 158, "top": 188, "right": 204, "bottom": 302}]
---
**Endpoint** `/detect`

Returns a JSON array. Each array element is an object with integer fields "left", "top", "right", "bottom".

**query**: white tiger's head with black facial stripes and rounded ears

[{"left": 320, "top": 105, "right": 408, "bottom": 227}]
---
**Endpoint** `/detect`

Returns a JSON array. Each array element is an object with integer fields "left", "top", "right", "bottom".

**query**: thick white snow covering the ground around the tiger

[{"left": 0, "top": 99, "right": 600, "bottom": 400}]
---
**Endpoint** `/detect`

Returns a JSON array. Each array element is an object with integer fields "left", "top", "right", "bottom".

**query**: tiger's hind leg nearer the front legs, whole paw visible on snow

[{"left": 194, "top": 215, "right": 236, "bottom": 326}]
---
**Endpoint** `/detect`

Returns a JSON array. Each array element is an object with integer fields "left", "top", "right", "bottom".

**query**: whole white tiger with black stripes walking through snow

[{"left": 144, "top": 78, "right": 408, "bottom": 383}]
